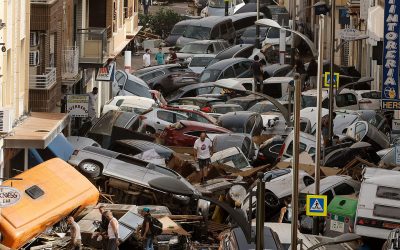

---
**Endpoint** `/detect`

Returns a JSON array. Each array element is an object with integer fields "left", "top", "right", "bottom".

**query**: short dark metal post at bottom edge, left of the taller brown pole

[{"left": 256, "top": 172, "right": 265, "bottom": 250}]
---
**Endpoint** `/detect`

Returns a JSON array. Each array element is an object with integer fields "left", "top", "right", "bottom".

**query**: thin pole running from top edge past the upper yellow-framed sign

[{"left": 329, "top": 0, "right": 336, "bottom": 143}]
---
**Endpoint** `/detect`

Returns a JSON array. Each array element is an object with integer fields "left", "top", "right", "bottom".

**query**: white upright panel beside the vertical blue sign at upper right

[{"left": 367, "top": 5, "right": 384, "bottom": 46}]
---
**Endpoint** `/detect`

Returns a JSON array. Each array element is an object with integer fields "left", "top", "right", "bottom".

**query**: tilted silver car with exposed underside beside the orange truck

[{"left": 69, "top": 147, "right": 199, "bottom": 212}]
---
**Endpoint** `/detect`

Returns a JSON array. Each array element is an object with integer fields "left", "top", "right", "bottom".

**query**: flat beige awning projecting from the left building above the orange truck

[{"left": 4, "top": 112, "right": 69, "bottom": 149}]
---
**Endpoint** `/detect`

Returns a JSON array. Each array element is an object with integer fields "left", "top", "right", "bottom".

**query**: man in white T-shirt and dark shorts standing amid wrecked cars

[{"left": 193, "top": 132, "right": 212, "bottom": 183}]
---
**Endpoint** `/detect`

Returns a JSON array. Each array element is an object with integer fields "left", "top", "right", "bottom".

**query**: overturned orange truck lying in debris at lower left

[{"left": 0, "top": 158, "right": 99, "bottom": 249}]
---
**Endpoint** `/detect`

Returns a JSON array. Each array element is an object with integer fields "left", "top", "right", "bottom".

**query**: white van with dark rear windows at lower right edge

[{"left": 354, "top": 168, "right": 400, "bottom": 239}]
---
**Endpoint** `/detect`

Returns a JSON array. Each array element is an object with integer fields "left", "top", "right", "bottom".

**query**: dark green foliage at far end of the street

[{"left": 139, "top": 8, "right": 182, "bottom": 37}]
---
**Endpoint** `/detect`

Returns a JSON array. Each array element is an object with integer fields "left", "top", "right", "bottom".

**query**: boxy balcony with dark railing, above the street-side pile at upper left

[{"left": 77, "top": 28, "right": 108, "bottom": 64}]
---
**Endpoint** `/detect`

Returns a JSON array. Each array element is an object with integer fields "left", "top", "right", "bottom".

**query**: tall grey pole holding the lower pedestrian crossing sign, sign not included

[{"left": 313, "top": 15, "right": 325, "bottom": 235}]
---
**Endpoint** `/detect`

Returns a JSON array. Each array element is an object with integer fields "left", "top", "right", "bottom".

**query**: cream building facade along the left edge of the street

[{"left": 0, "top": 0, "right": 30, "bottom": 176}]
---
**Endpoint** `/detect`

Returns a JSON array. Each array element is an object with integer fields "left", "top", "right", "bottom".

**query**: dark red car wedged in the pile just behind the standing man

[{"left": 160, "top": 121, "right": 231, "bottom": 147}]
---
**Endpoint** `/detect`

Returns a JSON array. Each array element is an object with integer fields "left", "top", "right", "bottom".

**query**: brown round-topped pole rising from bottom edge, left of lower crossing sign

[{"left": 291, "top": 74, "right": 301, "bottom": 250}]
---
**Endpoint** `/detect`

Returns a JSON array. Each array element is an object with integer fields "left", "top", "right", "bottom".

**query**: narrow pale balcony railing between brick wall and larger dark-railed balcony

[{"left": 61, "top": 46, "right": 79, "bottom": 80}]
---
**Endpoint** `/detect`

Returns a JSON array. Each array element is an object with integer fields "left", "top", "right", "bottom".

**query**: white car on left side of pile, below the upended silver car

[{"left": 101, "top": 96, "right": 155, "bottom": 115}]
